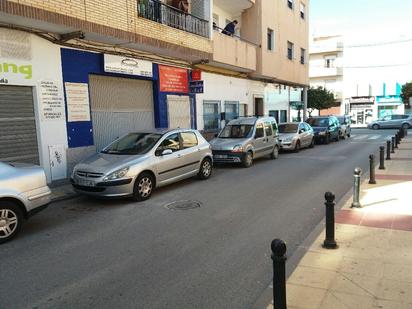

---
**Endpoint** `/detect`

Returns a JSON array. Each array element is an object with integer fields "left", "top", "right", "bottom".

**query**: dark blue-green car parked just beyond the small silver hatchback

[{"left": 306, "top": 116, "right": 340, "bottom": 144}]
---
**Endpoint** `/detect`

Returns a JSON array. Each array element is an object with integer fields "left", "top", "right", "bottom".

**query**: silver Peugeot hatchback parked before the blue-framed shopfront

[{"left": 70, "top": 129, "right": 213, "bottom": 201}]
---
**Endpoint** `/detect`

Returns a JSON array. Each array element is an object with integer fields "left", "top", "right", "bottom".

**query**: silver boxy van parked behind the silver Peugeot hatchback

[{"left": 210, "top": 117, "right": 280, "bottom": 167}]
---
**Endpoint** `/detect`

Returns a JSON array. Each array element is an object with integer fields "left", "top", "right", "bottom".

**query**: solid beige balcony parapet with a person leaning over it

[{"left": 210, "top": 31, "right": 257, "bottom": 72}]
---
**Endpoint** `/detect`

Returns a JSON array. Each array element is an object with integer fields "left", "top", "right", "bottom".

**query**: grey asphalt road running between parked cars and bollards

[{"left": 0, "top": 129, "right": 400, "bottom": 309}]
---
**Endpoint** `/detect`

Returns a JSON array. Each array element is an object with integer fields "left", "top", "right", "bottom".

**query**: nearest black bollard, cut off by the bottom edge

[{"left": 270, "top": 239, "right": 286, "bottom": 309}]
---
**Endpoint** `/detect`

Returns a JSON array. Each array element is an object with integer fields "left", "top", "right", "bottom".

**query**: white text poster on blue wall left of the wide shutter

[{"left": 38, "top": 80, "right": 64, "bottom": 121}]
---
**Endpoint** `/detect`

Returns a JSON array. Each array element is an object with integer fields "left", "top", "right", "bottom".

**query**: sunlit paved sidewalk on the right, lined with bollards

[{"left": 256, "top": 135, "right": 412, "bottom": 309}]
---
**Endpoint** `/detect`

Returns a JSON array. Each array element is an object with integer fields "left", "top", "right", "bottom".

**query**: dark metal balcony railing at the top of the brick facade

[{"left": 137, "top": 0, "right": 209, "bottom": 38}]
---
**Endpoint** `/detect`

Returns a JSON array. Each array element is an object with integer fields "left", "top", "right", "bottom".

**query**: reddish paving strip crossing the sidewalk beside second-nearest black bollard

[{"left": 335, "top": 209, "right": 412, "bottom": 231}]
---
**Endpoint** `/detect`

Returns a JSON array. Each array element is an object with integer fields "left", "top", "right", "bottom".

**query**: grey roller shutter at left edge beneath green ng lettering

[{"left": 0, "top": 86, "right": 39, "bottom": 165}]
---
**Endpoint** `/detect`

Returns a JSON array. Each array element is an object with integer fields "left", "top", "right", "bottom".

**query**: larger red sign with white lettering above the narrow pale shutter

[{"left": 159, "top": 65, "right": 189, "bottom": 93}]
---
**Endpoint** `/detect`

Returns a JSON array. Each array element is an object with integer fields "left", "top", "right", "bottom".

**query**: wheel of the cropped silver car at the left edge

[{"left": 0, "top": 201, "right": 23, "bottom": 244}]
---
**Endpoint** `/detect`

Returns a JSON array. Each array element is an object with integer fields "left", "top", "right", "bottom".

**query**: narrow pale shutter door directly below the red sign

[{"left": 167, "top": 95, "right": 191, "bottom": 128}]
